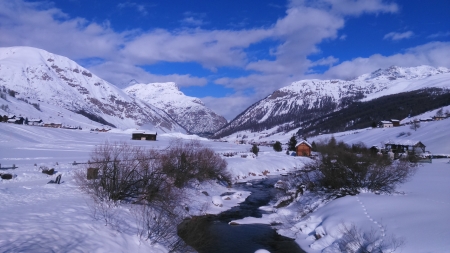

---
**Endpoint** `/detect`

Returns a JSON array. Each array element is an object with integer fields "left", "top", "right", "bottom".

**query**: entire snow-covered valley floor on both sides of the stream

[{"left": 0, "top": 115, "right": 450, "bottom": 252}]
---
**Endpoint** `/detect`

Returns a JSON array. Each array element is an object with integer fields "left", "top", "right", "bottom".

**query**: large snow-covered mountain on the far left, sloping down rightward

[{"left": 0, "top": 47, "right": 185, "bottom": 132}]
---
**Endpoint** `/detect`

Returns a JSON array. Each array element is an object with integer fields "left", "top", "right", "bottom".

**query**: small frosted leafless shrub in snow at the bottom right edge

[{"left": 337, "top": 224, "right": 404, "bottom": 253}]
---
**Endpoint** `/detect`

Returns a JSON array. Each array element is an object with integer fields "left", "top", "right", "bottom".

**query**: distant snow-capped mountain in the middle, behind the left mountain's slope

[{"left": 124, "top": 82, "right": 227, "bottom": 134}]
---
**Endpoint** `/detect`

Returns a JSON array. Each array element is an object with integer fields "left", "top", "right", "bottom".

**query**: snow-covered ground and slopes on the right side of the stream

[{"left": 222, "top": 114, "right": 450, "bottom": 253}]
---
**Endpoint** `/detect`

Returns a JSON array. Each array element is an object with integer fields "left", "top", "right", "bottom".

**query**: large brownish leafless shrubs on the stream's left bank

[{"left": 75, "top": 140, "right": 230, "bottom": 251}]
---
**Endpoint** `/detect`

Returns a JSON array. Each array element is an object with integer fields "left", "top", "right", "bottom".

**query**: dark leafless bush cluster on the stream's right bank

[{"left": 288, "top": 138, "right": 416, "bottom": 195}]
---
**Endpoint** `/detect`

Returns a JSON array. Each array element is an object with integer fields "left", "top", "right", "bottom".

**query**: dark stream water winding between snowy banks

[{"left": 178, "top": 177, "right": 305, "bottom": 253}]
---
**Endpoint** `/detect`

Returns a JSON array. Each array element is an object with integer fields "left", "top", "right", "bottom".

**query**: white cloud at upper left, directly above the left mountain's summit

[{"left": 0, "top": 0, "right": 125, "bottom": 59}]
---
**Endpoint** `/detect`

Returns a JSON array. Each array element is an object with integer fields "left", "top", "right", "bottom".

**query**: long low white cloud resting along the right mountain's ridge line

[{"left": 322, "top": 42, "right": 450, "bottom": 79}]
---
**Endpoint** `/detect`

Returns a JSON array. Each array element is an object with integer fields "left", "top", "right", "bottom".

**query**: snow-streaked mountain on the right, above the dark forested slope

[{"left": 215, "top": 66, "right": 450, "bottom": 137}]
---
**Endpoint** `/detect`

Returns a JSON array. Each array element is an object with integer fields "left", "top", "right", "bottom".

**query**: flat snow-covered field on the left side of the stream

[{"left": 0, "top": 123, "right": 305, "bottom": 252}]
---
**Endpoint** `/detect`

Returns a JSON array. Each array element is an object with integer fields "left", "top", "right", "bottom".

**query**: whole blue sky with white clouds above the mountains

[{"left": 0, "top": 0, "right": 450, "bottom": 120}]
